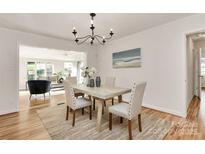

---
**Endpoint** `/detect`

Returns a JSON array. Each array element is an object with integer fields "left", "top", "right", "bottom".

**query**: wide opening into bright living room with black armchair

[{"left": 19, "top": 45, "right": 87, "bottom": 111}]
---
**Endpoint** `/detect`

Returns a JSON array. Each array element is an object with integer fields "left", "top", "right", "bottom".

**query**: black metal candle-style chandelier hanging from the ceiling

[{"left": 72, "top": 13, "right": 114, "bottom": 45}]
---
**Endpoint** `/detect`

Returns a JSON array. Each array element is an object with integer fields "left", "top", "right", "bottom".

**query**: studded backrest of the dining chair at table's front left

[{"left": 63, "top": 80, "right": 76, "bottom": 108}]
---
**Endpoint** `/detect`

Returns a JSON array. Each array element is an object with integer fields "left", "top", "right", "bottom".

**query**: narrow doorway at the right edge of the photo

[{"left": 186, "top": 32, "right": 205, "bottom": 109}]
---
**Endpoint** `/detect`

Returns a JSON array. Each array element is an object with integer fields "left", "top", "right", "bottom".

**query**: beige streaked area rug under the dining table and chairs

[{"left": 37, "top": 104, "right": 172, "bottom": 140}]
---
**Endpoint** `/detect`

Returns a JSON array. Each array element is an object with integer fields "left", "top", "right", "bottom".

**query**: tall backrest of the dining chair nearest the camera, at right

[{"left": 129, "top": 82, "right": 146, "bottom": 120}]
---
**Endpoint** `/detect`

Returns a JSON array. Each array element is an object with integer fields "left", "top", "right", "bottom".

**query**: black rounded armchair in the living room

[{"left": 28, "top": 80, "right": 51, "bottom": 100}]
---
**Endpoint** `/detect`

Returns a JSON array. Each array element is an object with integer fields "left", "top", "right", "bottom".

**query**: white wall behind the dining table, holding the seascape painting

[{"left": 97, "top": 15, "right": 205, "bottom": 117}]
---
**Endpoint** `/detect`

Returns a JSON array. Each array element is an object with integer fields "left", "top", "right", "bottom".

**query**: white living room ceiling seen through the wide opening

[{"left": 19, "top": 45, "right": 86, "bottom": 61}]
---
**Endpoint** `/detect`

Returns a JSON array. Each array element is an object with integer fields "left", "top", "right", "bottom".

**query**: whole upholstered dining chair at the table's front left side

[{"left": 63, "top": 81, "right": 92, "bottom": 126}]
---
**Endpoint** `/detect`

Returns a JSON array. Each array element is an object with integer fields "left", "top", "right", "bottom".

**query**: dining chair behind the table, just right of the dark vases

[{"left": 93, "top": 76, "right": 115, "bottom": 111}]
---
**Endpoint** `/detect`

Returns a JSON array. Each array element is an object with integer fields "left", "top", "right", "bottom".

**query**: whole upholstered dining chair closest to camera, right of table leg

[{"left": 108, "top": 82, "right": 146, "bottom": 140}]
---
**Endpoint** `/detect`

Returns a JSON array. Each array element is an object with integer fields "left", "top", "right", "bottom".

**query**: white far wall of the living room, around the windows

[{"left": 19, "top": 57, "right": 77, "bottom": 90}]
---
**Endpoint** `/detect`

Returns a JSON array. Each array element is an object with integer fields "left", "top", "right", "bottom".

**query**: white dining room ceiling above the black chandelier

[{"left": 0, "top": 13, "right": 193, "bottom": 40}]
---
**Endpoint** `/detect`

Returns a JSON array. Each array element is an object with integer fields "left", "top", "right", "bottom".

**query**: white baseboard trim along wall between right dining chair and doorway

[{"left": 142, "top": 103, "right": 187, "bottom": 118}]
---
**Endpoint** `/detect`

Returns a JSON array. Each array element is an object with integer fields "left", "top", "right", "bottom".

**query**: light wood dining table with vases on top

[{"left": 72, "top": 84, "right": 131, "bottom": 131}]
